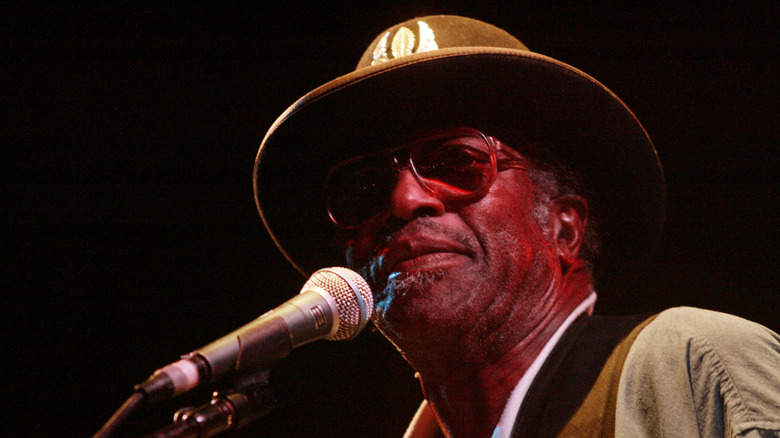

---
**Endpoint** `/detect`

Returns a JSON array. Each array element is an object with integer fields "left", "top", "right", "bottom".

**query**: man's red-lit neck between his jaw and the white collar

[{"left": 406, "top": 265, "right": 591, "bottom": 437}]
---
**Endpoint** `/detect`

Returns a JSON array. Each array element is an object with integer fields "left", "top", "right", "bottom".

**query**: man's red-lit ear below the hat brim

[{"left": 550, "top": 195, "right": 588, "bottom": 272}]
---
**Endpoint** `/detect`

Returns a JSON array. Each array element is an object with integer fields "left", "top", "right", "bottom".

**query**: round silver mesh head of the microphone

[{"left": 302, "top": 267, "right": 374, "bottom": 341}]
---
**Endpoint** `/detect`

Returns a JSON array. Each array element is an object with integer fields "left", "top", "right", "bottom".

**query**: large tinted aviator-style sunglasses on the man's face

[{"left": 324, "top": 129, "right": 524, "bottom": 229}]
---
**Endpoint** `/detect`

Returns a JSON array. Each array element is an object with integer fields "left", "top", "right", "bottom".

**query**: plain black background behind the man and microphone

[{"left": 0, "top": 1, "right": 780, "bottom": 437}]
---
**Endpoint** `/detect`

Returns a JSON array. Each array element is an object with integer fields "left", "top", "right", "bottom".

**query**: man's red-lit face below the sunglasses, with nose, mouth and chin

[{"left": 347, "top": 132, "right": 560, "bottom": 345}]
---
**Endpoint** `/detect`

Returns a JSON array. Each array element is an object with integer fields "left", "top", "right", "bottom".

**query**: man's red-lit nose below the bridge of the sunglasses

[{"left": 390, "top": 168, "right": 446, "bottom": 221}]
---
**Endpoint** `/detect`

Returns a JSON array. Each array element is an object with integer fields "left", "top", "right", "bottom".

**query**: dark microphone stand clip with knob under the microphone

[{"left": 144, "top": 369, "right": 275, "bottom": 438}]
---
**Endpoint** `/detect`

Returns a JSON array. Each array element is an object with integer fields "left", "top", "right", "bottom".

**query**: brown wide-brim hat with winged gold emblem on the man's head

[{"left": 254, "top": 16, "right": 665, "bottom": 289}]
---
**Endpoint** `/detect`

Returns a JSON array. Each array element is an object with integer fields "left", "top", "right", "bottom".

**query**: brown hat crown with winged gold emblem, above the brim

[{"left": 357, "top": 15, "right": 528, "bottom": 70}]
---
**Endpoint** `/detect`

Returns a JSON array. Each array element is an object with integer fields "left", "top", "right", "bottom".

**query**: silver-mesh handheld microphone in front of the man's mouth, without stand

[{"left": 135, "top": 267, "right": 374, "bottom": 402}]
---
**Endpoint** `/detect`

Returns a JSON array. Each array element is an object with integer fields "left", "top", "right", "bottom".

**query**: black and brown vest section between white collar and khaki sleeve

[{"left": 512, "top": 315, "right": 654, "bottom": 438}]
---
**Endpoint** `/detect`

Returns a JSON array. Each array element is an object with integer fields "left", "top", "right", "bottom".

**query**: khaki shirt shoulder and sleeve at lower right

[{"left": 616, "top": 307, "right": 780, "bottom": 436}]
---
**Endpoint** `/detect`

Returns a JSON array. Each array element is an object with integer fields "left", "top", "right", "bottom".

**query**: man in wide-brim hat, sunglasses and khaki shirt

[{"left": 255, "top": 16, "right": 780, "bottom": 437}]
